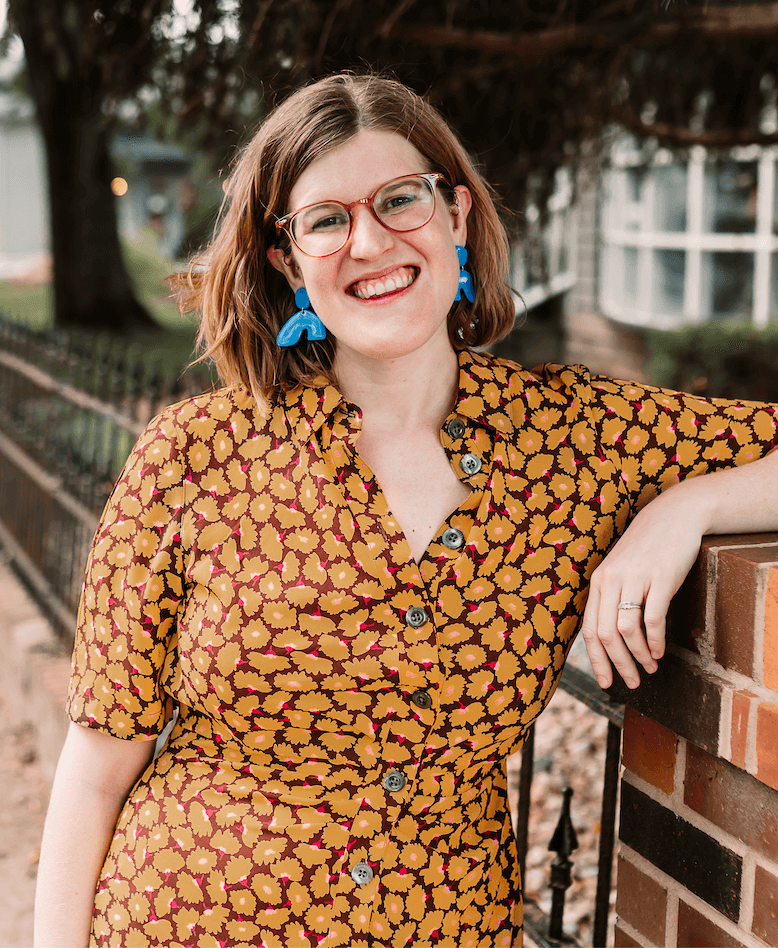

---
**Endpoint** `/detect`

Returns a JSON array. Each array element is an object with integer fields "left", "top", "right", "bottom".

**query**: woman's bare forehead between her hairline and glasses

[{"left": 289, "top": 129, "right": 430, "bottom": 209}]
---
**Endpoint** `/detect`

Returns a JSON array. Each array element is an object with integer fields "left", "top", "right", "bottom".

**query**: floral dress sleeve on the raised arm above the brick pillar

[{"left": 589, "top": 377, "right": 778, "bottom": 506}]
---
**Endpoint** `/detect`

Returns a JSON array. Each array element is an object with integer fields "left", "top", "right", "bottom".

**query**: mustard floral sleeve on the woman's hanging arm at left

[{"left": 66, "top": 409, "right": 186, "bottom": 740}]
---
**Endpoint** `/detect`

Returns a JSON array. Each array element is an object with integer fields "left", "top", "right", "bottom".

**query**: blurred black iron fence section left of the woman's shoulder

[{"left": 0, "top": 317, "right": 212, "bottom": 639}]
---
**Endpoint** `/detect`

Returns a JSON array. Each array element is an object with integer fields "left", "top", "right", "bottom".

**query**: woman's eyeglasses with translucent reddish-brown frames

[{"left": 276, "top": 172, "right": 445, "bottom": 257}]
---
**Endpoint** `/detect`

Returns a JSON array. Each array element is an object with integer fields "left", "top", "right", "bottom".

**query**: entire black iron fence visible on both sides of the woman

[{"left": 0, "top": 317, "right": 623, "bottom": 948}]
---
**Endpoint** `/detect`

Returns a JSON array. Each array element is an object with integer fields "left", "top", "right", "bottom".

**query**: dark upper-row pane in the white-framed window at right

[{"left": 703, "top": 160, "right": 756, "bottom": 234}]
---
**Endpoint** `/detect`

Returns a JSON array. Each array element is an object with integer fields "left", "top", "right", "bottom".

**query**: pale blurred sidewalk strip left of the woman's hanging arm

[{"left": 0, "top": 548, "right": 70, "bottom": 948}]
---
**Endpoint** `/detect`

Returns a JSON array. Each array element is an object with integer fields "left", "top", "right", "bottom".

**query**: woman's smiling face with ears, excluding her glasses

[{"left": 268, "top": 130, "right": 471, "bottom": 363}]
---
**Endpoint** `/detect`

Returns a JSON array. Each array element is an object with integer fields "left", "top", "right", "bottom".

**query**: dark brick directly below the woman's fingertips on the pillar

[{"left": 607, "top": 654, "right": 726, "bottom": 754}]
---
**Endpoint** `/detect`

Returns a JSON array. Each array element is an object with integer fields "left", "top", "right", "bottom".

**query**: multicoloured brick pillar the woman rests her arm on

[{"left": 614, "top": 534, "right": 778, "bottom": 948}]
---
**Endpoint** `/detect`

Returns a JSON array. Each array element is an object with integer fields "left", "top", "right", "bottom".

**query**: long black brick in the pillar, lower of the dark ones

[{"left": 619, "top": 783, "right": 743, "bottom": 921}]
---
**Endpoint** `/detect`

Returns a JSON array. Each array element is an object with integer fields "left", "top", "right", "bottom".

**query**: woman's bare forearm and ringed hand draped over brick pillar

[{"left": 581, "top": 449, "right": 778, "bottom": 688}]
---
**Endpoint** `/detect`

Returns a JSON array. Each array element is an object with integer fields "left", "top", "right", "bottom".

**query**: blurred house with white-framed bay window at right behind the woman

[{"left": 564, "top": 137, "right": 778, "bottom": 380}]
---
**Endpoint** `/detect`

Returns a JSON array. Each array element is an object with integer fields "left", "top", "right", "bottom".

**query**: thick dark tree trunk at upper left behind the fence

[{"left": 11, "top": 0, "right": 157, "bottom": 332}]
